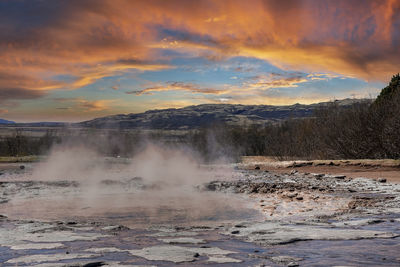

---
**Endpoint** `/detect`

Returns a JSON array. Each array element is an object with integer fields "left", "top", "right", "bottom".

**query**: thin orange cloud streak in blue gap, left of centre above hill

[{"left": 126, "top": 82, "right": 227, "bottom": 95}]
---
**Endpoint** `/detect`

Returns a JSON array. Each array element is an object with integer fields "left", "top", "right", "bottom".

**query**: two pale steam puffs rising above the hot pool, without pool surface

[{"left": 33, "top": 144, "right": 222, "bottom": 187}]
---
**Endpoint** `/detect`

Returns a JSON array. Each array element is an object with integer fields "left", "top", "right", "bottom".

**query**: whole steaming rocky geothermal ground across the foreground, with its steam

[{"left": 0, "top": 145, "right": 400, "bottom": 266}]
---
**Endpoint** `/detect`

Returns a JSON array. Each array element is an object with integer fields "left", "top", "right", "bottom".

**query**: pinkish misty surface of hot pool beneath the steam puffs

[{"left": 2, "top": 192, "right": 261, "bottom": 227}]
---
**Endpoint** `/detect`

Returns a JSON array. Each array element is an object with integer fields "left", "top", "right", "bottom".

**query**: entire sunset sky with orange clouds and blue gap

[{"left": 0, "top": 0, "right": 400, "bottom": 122}]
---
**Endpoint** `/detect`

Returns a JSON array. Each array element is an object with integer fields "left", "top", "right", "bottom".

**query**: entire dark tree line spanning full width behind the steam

[{"left": 0, "top": 74, "right": 400, "bottom": 161}]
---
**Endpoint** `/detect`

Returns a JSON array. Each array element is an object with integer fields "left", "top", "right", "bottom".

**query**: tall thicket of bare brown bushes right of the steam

[{"left": 188, "top": 74, "right": 400, "bottom": 160}]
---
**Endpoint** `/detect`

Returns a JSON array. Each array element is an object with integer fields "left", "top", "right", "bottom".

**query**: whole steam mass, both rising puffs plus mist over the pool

[{"left": 23, "top": 144, "right": 252, "bottom": 225}]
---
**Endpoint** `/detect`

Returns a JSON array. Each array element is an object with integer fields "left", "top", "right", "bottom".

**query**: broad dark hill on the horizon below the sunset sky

[{"left": 75, "top": 99, "right": 370, "bottom": 130}]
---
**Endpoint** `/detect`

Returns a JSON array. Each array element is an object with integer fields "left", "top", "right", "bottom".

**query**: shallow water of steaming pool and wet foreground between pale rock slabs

[{"left": 0, "top": 162, "right": 400, "bottom": 266}]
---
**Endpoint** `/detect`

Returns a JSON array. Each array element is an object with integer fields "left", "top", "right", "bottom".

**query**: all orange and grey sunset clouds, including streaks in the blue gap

[{"left": 0, "top": 0, "right": 400, "bottom": 108}]
